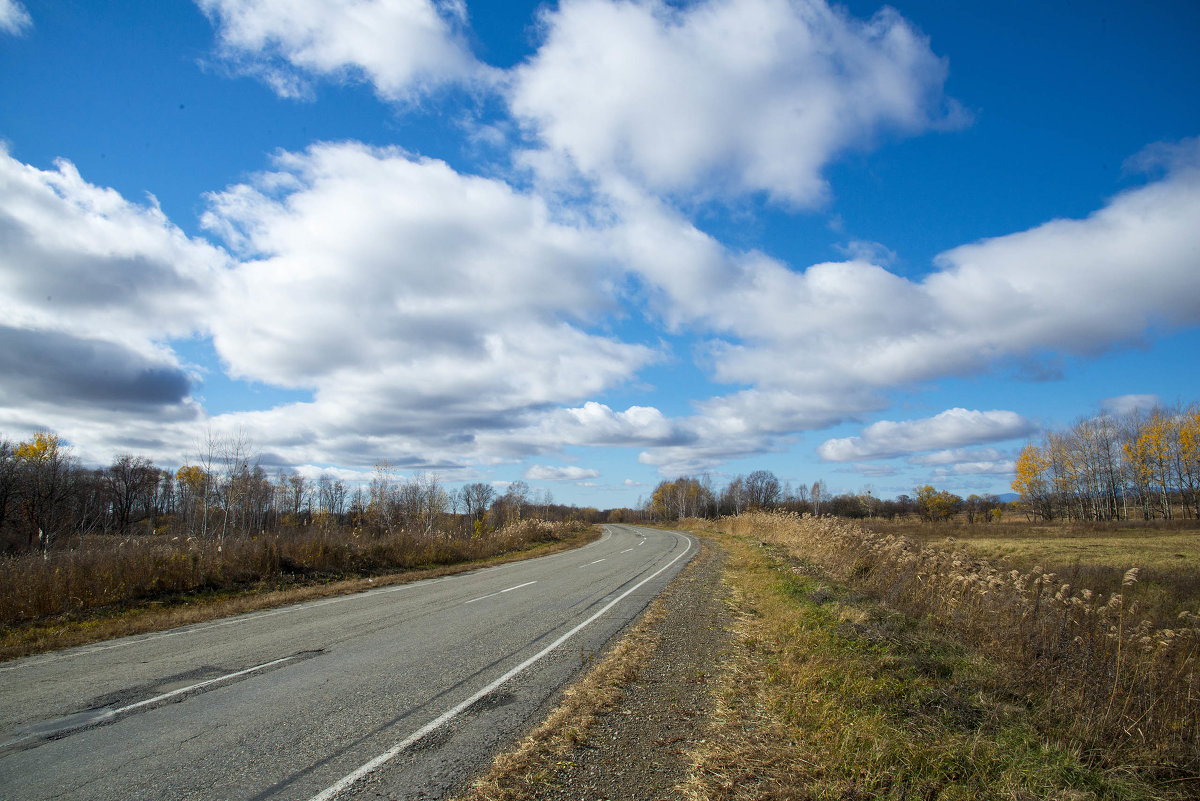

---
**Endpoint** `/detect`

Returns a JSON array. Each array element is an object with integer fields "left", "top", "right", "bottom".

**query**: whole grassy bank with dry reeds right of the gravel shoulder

[{"left": 685, "top": 514, "right": 1200, "bottom": 801}]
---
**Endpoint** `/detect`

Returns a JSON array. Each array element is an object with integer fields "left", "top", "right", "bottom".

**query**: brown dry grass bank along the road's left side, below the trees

[{"left": 0, "top": 520, "right": 598, "bottom": 660}]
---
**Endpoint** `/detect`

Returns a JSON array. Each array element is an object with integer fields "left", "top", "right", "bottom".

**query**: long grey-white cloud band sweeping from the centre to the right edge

[{"left": 614, "top": 140, "right": 1200, "bottom": 464}]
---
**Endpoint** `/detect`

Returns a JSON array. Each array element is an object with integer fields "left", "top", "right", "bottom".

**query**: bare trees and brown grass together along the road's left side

[{"left": 0, "top": 433, "right": 599, "bottom": 658}]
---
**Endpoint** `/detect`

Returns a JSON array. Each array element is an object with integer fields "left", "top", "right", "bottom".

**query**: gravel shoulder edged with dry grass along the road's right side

[{"left": 460, "top": 532, "right": 731, "bottom": 801}]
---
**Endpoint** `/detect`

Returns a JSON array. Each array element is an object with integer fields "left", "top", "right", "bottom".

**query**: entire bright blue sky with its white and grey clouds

[{"left": 0, "top": 0, "right": 1200, "bottom": 507}]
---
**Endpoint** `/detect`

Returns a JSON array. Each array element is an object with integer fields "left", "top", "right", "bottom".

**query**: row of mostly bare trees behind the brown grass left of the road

[{"left": 0, "top": 432, "right": 602, "bottom": 553}]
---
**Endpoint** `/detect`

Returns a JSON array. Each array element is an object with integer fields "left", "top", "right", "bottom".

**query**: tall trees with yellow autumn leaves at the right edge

[{"left": 1013, "top": 404, "right": 1200, "bottom": 520}]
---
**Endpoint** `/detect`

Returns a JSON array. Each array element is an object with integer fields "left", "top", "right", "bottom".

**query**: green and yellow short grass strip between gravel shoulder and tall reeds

[{"left": 683, "top": 525, "right": 1168, "bottom": 801}]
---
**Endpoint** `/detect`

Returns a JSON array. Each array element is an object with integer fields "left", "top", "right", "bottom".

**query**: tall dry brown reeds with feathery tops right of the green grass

[{"left": 718, "top": 513, "right": 1200, "bottom": 776}]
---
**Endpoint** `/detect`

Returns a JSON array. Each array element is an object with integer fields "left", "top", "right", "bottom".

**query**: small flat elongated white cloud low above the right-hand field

[{"left": 817, "top": 409, "right": 1036, "bottom": 462}]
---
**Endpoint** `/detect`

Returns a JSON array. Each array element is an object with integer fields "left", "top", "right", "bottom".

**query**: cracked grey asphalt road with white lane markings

[{"left": 0, "top": 525, "right": 696, "bottom": 801}]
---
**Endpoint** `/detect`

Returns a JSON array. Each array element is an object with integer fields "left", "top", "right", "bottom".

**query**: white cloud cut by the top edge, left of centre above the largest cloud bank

[{"left": 197, "top": 0, "right": 486, "bottom": 101}]
